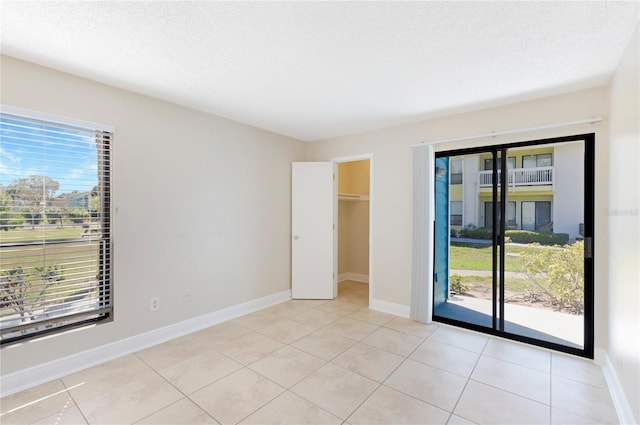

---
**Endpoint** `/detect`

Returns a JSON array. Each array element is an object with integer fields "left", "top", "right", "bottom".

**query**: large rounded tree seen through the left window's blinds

[{"left": 6, "top": 175, "right": 60, "bottom": 229}]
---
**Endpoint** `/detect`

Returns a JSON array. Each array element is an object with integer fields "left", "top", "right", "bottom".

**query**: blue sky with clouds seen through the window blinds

[{"left": 0, "top": 114, "right": 98, "bottom": 196}]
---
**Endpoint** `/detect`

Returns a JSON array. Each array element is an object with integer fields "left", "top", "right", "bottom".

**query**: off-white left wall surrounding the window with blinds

[{"left": 0, "top": 56, "right": 306, "bottom": 375}]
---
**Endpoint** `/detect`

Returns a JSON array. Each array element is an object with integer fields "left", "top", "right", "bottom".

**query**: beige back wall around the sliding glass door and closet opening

[{"left": 308, "top": 87, "right": 609, "bottom": 347}]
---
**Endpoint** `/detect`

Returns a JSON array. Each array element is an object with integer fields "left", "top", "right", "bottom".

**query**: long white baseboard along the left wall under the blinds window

[{"left": 0, "top": 290, "right": 291, "bottom": 397}]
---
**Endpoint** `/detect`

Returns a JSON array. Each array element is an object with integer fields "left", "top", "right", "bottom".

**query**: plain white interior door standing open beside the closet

[{"left": 291, "top": 162, "right": 336, "bottom": 299}]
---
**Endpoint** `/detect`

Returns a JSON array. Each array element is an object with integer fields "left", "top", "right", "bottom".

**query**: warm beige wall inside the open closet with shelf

[{"left": 338, "top": 160, "right": 369, "bottom": 275}]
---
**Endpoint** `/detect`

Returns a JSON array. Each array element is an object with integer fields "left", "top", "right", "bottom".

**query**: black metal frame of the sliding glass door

[{"left": 432, "top": 133, "right": 595, "bottom": 359}]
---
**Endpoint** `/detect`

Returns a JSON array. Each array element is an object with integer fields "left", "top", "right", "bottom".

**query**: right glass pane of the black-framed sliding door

[{"left": 504, "top": 142, "right": 584, "bottom": 348}]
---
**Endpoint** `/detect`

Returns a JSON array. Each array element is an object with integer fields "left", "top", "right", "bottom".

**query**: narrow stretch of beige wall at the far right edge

[{"left": 607, "top": 24, "right": 640, "bottom": 423}]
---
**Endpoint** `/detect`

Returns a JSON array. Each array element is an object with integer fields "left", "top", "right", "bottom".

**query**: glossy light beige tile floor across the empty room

[{"left": 0, "top": 282, "right": 617, "bottom": 425}]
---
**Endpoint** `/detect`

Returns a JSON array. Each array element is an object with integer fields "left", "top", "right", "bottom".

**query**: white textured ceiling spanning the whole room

[{"left": 0, "top": 0, "right": 640, "bottom": 141}]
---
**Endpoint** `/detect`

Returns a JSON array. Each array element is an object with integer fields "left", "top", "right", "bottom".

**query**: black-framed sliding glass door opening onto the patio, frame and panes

[{"left": 433, "top": 134, "right": 594, "bottom": 357}]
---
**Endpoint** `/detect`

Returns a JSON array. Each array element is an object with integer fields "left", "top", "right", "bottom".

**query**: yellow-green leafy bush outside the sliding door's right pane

[{"left": 520, "top": 241, "right": 584, "bottom": 314}]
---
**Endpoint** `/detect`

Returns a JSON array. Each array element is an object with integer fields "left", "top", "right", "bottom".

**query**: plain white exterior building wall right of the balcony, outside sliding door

[{"left": 553, "top": 142, "right": 584, "bottom": 239}]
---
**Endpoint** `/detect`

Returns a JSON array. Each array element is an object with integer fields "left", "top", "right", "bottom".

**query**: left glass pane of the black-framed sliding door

[{"left": 434, "top": 154, "right": 493, "bottom": 328}]
